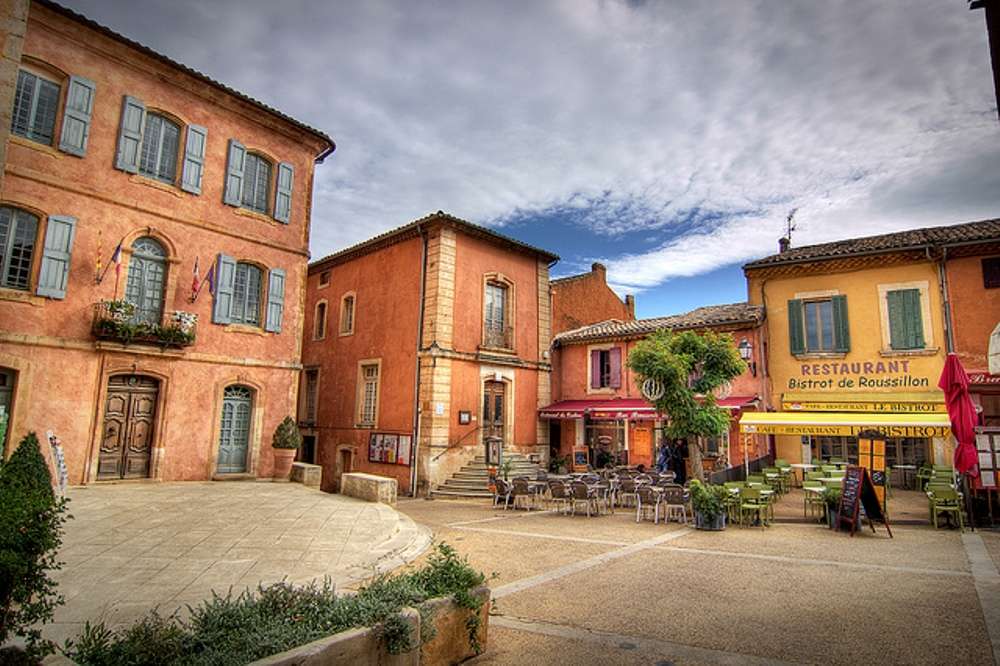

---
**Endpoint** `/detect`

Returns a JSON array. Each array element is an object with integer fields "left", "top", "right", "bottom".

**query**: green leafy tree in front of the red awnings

[{"left": 628, "top": 330, "right": 746, "bottom": 480}]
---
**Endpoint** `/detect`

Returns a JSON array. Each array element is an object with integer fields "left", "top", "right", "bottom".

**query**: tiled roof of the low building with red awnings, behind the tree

[{"left": 555, "top": 303, "right": 764, "bottom": 344}]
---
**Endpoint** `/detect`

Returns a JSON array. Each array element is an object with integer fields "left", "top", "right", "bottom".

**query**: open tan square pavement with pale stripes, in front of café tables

[{"left": 398, "top": 500, "right": 1000, "bottom": 666}]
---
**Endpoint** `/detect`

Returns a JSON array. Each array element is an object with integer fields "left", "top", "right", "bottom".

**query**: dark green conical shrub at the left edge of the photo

[{"left": 0, "top": 432, "right": 67, "bottom": 658}]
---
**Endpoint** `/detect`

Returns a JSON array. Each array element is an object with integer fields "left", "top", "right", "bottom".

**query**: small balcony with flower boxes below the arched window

[{"left": 92, "top": 300, "right": 198, "bottom": 349}]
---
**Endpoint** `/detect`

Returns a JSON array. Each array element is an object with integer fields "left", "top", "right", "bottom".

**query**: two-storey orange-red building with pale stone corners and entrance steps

[{"left": 299, "top": 211, "right": 557, "bottom": 493}]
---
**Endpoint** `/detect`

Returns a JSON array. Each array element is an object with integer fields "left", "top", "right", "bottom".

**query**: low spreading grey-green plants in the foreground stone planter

[{"left": 63, "top": 544, "right": 485, "bottom": 666}]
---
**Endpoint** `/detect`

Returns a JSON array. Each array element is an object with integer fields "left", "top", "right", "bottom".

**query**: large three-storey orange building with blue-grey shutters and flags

[{"left": 0, "top": 0, "right": 334, "bottom": 483}]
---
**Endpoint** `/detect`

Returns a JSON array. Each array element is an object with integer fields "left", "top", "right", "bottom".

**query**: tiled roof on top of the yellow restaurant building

[{"left": 743, "top": 219, "right": 1000, "bottom": 269}]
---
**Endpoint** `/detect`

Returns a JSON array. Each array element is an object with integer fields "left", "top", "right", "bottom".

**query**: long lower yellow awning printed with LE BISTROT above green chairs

[{"left": 740, "top": 412, "right": 951, "bottom": 437}]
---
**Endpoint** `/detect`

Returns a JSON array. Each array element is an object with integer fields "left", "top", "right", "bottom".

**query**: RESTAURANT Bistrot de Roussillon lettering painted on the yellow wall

[{"left": 787, "top": 359, "right": 934, "bottom": 391}]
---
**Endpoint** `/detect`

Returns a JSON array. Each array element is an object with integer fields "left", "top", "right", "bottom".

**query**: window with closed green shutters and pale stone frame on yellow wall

[{"left": 878, "top": 281, "right": 934, "bottom": 354}]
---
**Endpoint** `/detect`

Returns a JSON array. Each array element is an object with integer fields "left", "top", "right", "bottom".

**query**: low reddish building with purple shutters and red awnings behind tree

[{"left": 541, "top": 303, "right": 768, "bottom": 469}]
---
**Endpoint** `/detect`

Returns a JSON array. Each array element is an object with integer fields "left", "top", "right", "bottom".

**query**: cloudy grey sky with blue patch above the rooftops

[{"left": 64, "top": 0, "right": 1000, "bottom": 316}]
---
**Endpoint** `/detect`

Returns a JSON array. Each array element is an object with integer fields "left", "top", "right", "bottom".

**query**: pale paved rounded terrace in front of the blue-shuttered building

[{"left": 45, "top": 481, "right": 430, "bottom": 643}]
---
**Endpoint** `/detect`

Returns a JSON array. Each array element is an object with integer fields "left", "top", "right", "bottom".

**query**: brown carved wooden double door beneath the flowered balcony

[{"left": 97, "top": 375, "right": 160, "bottom": 480}]
